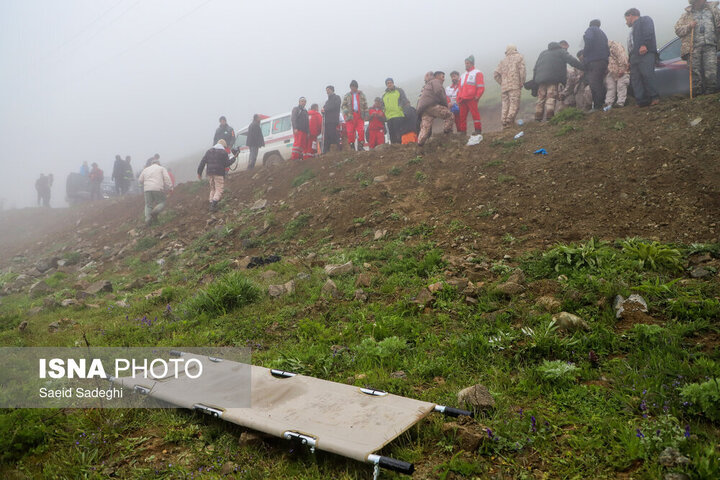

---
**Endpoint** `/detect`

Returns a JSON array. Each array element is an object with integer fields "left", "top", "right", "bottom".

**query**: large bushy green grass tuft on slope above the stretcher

[{"left": 186, "top": 272, "right": 260, "bottom": 315}]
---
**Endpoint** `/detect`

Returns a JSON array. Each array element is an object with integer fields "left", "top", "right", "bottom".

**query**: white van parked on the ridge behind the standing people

[{"left": 233, "top": 112, "right": 293, "bottom": 169}]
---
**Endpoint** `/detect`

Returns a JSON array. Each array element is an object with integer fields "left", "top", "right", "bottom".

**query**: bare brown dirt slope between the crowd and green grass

[{"left": 0, "top": 96, "right": 720, "bottom": 267}]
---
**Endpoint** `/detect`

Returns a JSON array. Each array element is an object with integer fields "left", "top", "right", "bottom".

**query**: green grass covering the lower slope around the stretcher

[{"left": 0, "top": 238, "right": 720, "bottom": 479}]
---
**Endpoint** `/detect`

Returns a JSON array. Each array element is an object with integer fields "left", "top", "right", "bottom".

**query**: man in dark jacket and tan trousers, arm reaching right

[{"left": 533, "top": 42, "right": 584, "bottom": 122}]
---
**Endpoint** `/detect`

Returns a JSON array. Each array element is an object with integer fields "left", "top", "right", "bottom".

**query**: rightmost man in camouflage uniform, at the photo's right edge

[{"left": 675, "top": 0, "right": 720, "bottom": 95}]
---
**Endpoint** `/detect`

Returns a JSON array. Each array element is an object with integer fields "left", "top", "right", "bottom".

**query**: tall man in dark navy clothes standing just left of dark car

[{"left": 625, "top": 8, "right": 660, "bottom": 107}]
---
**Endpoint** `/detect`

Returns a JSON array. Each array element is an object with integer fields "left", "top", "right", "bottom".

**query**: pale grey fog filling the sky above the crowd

[{"left": 0, "top": 0, "right": 687, "bottom": 208}]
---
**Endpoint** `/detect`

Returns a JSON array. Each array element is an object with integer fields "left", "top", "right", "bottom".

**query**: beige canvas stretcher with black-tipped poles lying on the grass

[{"left": 110, "top": 351, "right": 472, "bottom": 478}]
